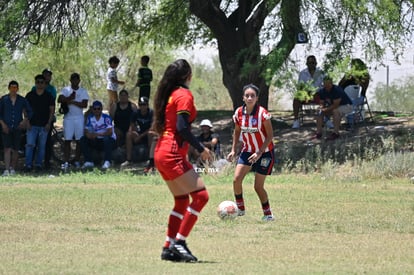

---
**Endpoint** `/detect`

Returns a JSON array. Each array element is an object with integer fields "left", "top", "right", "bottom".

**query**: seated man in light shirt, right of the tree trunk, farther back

[{"left": 292, "top": 55, "right": 332, "bottom": 129}]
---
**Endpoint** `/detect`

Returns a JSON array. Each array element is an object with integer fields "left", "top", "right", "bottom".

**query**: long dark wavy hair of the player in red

[{"left": 152, "top": 59, "right": 191, "bottom": 135}]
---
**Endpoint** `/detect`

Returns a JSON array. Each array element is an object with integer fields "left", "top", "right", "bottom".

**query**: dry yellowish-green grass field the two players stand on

[{"left": 0, "top": 171, "right": 414, "bottom": 274}]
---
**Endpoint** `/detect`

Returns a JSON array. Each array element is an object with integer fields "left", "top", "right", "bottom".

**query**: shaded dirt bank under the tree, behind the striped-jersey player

[{"left": 193, "top": 111, "right": 414, "bottom": 162}]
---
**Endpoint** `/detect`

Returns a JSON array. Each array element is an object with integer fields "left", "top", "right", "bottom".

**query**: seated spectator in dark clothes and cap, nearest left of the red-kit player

[{"left": 121, "top": 97, "right": 154, "bottom": 170}]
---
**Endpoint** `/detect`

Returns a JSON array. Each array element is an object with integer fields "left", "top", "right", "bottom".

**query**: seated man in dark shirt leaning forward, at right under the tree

[{"left": 315, "top": 76, "right": 352, "bottom": 140}]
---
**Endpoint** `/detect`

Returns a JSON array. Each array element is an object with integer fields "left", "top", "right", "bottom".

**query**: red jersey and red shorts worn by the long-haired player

[{"left": 154, "top": 87, "right": 197, "bottom": 180}]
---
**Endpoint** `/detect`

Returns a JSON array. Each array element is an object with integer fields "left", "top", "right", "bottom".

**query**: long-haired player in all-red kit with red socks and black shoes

[{"left": 152, "top": 59, "right": 210, "bottom": 262}]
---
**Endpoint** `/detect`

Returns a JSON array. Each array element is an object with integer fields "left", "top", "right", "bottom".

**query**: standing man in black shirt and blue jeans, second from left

[{"left": 25, "top": 74, "right": 55, "bottom": 172}]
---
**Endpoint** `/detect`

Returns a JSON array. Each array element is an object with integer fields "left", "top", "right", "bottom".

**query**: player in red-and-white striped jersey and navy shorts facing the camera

[{"left": 227, "top": 84, "right": 274, "bottom": 221}]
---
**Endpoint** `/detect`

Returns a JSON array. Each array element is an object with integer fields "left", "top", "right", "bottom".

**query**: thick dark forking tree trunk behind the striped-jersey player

[{"left": 190, "top": 0, "right": 302, "bottom": 109}]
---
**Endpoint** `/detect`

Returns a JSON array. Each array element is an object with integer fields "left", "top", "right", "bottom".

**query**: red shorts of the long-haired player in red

[{"left": 154, "top": 150, "right": 193, "bottom": 181}]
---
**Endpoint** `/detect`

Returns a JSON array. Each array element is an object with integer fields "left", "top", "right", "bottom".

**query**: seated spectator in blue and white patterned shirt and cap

[{"left": 80, "top": 100, "right": 116, "bottom": 169}]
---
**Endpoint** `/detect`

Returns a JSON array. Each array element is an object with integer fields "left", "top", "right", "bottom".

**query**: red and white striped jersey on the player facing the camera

[{"left": 233, "top": 105, "right": 273, "bottom": 153}]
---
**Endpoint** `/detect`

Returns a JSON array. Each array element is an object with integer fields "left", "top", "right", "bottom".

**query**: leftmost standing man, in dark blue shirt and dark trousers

[{"left": 0, "top": 80, "right": 32, "bottom": 176}]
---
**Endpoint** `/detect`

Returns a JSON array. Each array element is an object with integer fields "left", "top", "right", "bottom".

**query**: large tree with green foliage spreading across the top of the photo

[{"left": 0, "top": 0, "right": 414, "bottom": 108}]
